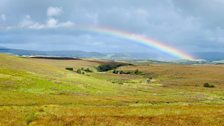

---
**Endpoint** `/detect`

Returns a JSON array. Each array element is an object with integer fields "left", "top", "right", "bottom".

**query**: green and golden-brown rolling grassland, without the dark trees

[{"left": 0, "top": 54, "right": 224, "bottom": 126}]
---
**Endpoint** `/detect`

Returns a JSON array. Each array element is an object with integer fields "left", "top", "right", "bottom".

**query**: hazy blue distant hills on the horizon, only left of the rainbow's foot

[{"left": 0, "top": 47, "right": 168, "bottom": 60}]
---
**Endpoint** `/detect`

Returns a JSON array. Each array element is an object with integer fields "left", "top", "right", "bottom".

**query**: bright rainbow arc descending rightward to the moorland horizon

[{"left": 75, "top": 26, "right": 195, "bottom": 60}]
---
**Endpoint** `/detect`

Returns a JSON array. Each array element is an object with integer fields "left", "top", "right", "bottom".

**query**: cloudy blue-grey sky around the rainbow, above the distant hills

[{"left": 0, "top": 0, "right": 224, "bottom": 57}]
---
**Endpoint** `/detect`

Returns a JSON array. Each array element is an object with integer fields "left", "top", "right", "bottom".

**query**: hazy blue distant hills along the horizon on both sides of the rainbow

[{"left": 0, "top": 47, "right": 224, "bottom": 63}]
